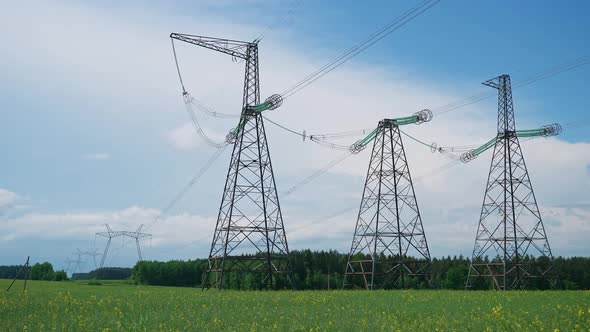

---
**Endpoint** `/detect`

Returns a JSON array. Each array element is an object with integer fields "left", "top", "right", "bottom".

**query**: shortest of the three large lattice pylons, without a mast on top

[{"left": 343, "top": 110, "right": 432, "bottom": 290}]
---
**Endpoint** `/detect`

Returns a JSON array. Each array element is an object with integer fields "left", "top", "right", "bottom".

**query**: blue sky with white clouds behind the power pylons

[{"left": 0, "top": 0, "right": 590, "bottom": 267}]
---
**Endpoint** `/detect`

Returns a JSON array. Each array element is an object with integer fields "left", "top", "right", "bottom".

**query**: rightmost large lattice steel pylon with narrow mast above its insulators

[{"left": 461, "top": 75, "right": 561, "bottom": 290}]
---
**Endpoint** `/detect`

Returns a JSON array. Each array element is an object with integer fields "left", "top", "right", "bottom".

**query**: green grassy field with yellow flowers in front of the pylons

[{"left": 0, "top": 280, "right": 590, "bottom": 331}]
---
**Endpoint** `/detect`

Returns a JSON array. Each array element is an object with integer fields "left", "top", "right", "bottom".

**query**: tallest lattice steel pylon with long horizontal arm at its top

[{"left": 170, "top": 33, "right": 293, "bottom": 289}]
